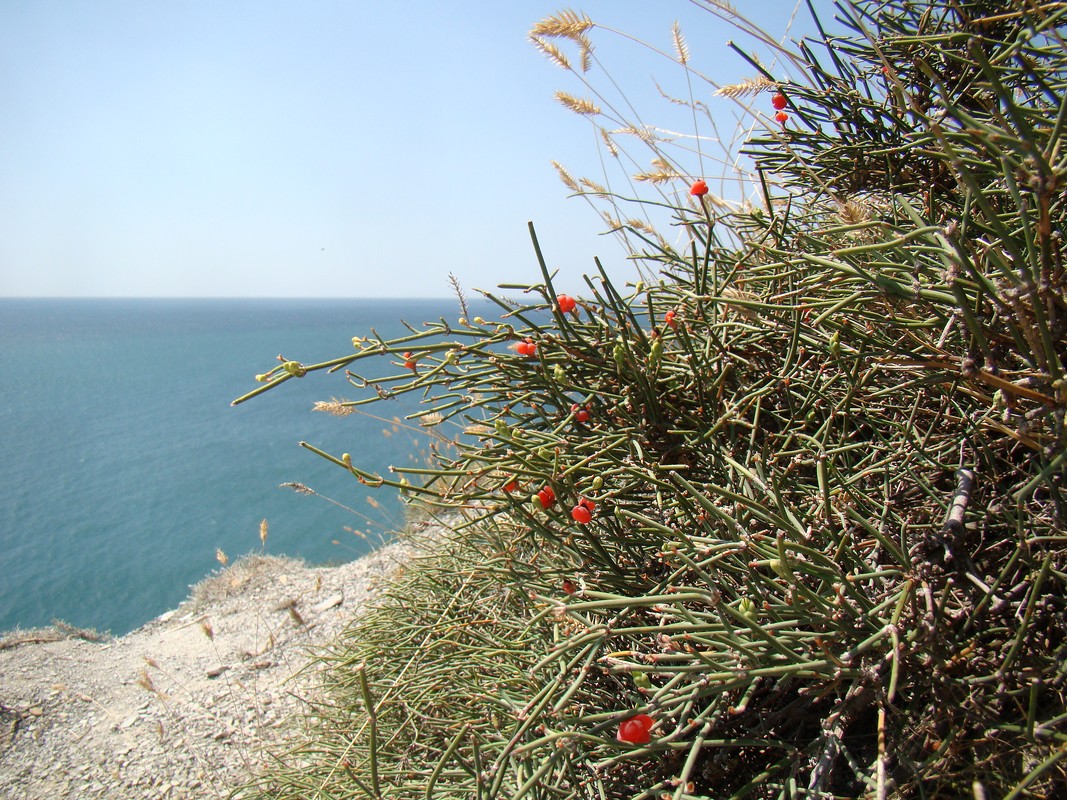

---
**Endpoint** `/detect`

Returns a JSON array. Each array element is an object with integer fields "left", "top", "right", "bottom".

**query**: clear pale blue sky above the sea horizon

[{"left": 0, "top": 0, "right": 830, "bottom": 297}]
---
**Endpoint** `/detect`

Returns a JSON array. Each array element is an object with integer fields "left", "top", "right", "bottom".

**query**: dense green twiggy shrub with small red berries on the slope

[{"left": 242, "top": 0, "right": 1067, "bottom": 798}]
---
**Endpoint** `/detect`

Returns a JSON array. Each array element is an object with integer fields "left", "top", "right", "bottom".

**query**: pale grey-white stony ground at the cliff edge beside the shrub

[{"left": 0, "top": 545, "right": 404, "bottom": 800}]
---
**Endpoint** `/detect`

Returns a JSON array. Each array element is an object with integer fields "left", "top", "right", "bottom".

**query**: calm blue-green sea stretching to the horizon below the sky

[{"left": 0, "top": 299, "right": 484, "bottom": 636}]
